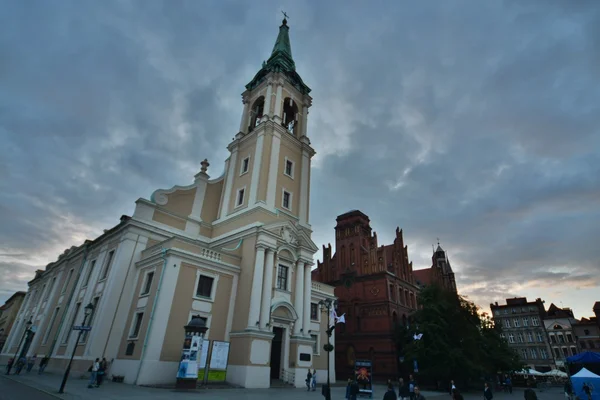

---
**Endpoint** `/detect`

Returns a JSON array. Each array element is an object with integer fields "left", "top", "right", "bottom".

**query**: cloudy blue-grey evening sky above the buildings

[{"left": 0, "top": 0, "right": 600, "bottom": 317}]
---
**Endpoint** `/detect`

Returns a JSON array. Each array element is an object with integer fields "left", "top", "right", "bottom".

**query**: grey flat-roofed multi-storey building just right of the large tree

[{"left": 490, "top": 297, "right": 555, "bottom": 372}]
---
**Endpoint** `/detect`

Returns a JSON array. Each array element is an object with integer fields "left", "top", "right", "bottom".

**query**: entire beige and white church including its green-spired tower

[{"left": 3, "top": 20, "right": 335, "bottom": 387}]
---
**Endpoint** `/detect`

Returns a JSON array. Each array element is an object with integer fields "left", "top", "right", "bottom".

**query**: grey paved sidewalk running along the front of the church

[{"left": 0, "top": 371, "right": 450, "bottom": 400}]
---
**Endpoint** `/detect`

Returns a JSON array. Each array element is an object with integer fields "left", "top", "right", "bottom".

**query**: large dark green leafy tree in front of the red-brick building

[{"left": 395, "top": 286, "right": 522, "bottom": 387}]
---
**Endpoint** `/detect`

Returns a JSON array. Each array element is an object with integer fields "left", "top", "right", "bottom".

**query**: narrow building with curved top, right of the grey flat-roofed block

[{"left": 544, "top": 304, "right": 578, "bottom": 368}]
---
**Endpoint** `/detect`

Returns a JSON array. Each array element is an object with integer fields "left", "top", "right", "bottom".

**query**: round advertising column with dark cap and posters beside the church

[{"left": 175, "top": 316, "right": 208, "bottom": 390}]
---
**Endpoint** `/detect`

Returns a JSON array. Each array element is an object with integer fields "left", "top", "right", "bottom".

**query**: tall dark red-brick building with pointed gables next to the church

[{"left": 312, "top": 210, "right": 418, "bottom": 379}]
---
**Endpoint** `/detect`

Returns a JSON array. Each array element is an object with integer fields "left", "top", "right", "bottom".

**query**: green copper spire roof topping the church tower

[{"left": 246, "top": 19, "right": 310, "bottom": 94}]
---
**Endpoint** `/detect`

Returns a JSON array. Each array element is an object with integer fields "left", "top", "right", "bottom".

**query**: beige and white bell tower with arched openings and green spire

[{"left": 218, "top": 19, "right": 315, "bottom": 228}]
